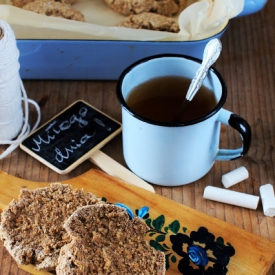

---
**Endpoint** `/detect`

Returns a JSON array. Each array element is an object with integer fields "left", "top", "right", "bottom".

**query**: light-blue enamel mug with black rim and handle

[{"left": 116, "top": 54, "right": 251, "bottom": 186}]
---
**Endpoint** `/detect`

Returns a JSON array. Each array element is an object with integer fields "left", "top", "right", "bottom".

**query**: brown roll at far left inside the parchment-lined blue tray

[{"left": 22, "top": 0, "right": 85, "bottom": 22}]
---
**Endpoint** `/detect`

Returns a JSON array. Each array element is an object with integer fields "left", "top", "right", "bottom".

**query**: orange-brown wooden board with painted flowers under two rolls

[{"left": 0, "top": 170, "right": 275, "bottom": 275}]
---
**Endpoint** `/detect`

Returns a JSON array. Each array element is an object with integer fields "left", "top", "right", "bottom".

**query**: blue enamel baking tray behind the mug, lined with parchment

[{"left": 17, "top": 0, "right": 267, "bottom": 80}]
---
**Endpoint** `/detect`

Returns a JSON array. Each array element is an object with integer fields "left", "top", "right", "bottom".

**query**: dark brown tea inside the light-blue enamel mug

[{"left": 126, "top": 76, "right": 217, "bottom": 123}]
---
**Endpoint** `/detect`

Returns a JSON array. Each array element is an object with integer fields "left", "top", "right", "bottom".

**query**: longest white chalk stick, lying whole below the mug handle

[{"left": 203, "top": 186, "right": 260, "bottom": 209}]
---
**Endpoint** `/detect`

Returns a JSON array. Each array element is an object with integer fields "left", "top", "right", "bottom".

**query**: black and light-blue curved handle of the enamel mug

[{"left": 215, "top": 108, "right": 251, "bottom": 160}]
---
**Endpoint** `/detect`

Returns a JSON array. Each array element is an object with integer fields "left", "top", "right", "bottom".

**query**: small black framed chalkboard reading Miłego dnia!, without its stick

[{"left": 20, "top": 100, "right": 121, "bottom": 174}]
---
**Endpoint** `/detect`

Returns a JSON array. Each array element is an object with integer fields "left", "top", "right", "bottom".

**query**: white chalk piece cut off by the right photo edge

[{"left": 260, "top": 183, "right": 275, "bottom": 217}]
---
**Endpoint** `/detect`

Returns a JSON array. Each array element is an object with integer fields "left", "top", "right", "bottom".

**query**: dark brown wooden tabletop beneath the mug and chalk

[{"left": 0, "top": 0, "right": 275, "bottom": 275}]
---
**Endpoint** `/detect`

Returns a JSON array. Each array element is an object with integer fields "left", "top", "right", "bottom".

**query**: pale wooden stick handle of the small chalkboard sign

[{"left": 89, "top": 150, "right": 155, "bottom": 193}]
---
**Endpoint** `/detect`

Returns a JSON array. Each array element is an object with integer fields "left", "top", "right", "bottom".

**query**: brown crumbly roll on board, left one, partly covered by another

[{"left": 0, "top": 183, "right": 103, "bottom": 271}]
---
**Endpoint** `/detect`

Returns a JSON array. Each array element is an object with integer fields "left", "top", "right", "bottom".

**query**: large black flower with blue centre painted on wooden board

[{"left": 170, "top": 227, "right": 235, "bottom": 275}]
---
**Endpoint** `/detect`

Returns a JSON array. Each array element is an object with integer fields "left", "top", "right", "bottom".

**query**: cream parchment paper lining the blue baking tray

[{"left": 0, "top": 0, "right": 244, "bottom": 41}]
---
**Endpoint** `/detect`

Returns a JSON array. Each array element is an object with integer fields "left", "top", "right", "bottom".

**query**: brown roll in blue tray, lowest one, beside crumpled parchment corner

[{"left": 117, "top": 12, "right": 180, "bottom": 33}]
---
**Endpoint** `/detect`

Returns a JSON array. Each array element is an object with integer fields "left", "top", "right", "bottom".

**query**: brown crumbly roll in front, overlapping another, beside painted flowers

[{"left": 56, "top": 204, "right": 165, "bottom": 275}]
